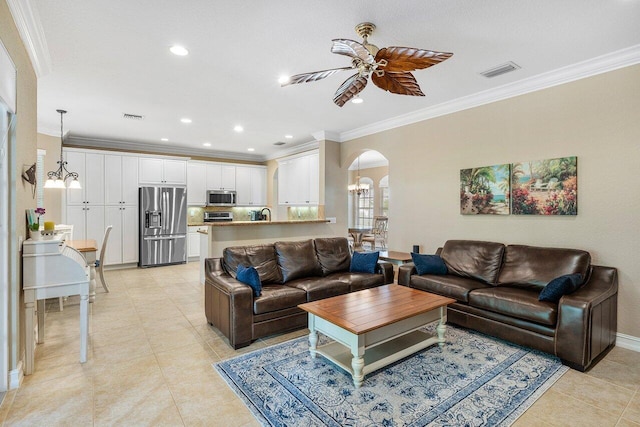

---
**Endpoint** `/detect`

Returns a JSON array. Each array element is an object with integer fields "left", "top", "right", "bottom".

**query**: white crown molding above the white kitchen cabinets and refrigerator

[{"left": 64, "top": 135, "right": 265, "bottom": 162}]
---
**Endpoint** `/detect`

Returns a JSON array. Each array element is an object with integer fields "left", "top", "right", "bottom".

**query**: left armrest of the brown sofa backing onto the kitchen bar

[{"left": 204, "top": 258, "right": 253, "bottom": 349}]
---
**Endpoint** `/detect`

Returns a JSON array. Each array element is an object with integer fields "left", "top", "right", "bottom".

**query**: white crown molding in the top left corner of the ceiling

[{"left": 7, "top": 0, "right": 51, "bottom": 78}]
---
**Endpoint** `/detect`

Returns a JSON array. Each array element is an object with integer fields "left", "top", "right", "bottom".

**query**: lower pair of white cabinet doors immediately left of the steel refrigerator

[{"left": 105, "top": 205, "right": 138, "bottom": 265}]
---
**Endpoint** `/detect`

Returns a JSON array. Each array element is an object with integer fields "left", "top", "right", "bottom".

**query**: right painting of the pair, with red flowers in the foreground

[{"left": 511, "top": 156, "right": 578, "bottom": 215}]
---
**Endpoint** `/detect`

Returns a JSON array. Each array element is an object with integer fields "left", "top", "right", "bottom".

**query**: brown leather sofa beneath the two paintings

[{"left": 398, "top": 240, "right": 618, "bottom": 371}]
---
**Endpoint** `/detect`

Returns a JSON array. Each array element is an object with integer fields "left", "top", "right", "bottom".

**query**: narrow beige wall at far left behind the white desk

[{"left": 0, "top": 1, "right": 37, "bottom": 382}]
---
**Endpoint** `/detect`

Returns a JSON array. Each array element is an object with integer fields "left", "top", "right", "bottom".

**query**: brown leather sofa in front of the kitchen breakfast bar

[{"left": 204, "top": 237, "right": 393, "bottom": 349}]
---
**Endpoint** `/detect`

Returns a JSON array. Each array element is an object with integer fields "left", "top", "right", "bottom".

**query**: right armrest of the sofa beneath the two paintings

[{"left": 555, "top": 265, "right": 618, "bottom": 371}]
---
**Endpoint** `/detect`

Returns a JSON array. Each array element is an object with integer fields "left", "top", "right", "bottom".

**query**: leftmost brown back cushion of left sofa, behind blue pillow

[{"left": 222, "top": 245, "right": 282, "bottom": 285}]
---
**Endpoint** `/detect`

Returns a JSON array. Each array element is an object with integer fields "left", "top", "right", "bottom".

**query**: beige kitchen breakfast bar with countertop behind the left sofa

[{"left": 195, "top": 219, "right": 332, "bottom": 283}]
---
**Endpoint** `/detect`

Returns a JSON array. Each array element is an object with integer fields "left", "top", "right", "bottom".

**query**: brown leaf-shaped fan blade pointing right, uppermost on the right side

[{"left": 375, "top": 46, "right": 453, "bottom": 72}]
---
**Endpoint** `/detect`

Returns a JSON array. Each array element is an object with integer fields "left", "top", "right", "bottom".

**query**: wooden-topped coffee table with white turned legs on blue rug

[{"left": 298, "top": 285, "right": 455, "bottom": 388}]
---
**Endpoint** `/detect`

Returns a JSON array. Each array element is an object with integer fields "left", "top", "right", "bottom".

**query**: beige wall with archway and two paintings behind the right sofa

[{"left": 342, "top": 65, "right": 640, "bottom": 337}]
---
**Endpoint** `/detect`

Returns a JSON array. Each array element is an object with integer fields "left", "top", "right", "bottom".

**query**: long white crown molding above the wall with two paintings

[{"left": 338, "top": 45, "right": 640, "bottom": 142}]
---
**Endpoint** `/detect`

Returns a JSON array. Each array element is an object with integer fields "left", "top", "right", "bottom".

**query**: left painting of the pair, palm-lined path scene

[{"left": 460, "top": 164, "right": 510, "bottom": 215}]
